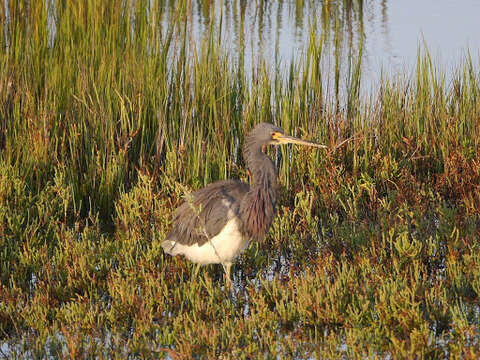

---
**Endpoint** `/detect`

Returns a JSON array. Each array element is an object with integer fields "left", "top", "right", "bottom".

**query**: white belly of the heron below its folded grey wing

[{"left": 162, "top": 219, "right": 249, "bottom": 265}]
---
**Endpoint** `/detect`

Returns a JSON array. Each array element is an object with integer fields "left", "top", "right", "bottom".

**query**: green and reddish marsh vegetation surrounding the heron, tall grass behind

[{"left": 0, "top": 0, "right": 480, "bottom": 358}]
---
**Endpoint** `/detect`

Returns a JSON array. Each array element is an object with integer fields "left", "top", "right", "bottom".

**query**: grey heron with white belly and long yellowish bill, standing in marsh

[{"left": 161, "top": 123, "right": 326, "bottom": 287}]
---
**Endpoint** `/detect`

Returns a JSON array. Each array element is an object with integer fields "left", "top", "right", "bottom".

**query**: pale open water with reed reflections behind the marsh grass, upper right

[{"left": 180, "top": 0, "right": 480, "bottom": 86}]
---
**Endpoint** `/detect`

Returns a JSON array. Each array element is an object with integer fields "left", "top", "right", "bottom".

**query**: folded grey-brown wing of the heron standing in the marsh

[{"left": 165, "top": 180, "right": 250, "bottom": 246}]
